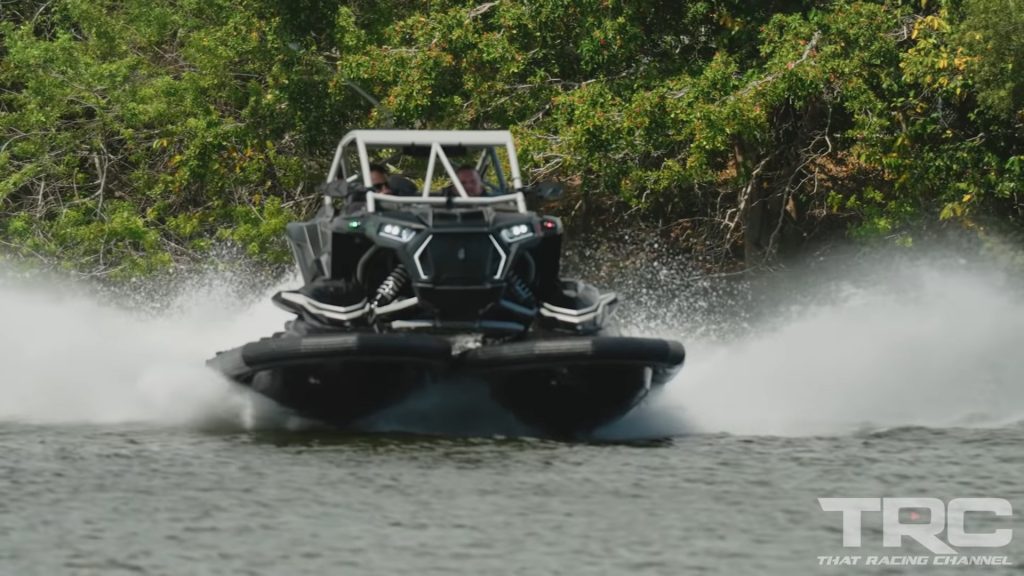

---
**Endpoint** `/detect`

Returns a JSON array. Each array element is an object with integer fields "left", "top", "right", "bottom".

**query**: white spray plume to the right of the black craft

[{"left": 605, "top": 260, "right": 1024, "bottom": 437}]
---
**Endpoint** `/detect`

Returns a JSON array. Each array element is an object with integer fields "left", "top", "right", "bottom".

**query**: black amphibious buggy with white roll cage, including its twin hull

[{"left": 208, "top": 130, "right": 685, "bottom": 436}]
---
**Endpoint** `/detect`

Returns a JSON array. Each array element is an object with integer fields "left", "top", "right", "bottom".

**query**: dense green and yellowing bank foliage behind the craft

[{"left": 0, "top": 0, "right": 1024, "bottom": 276}]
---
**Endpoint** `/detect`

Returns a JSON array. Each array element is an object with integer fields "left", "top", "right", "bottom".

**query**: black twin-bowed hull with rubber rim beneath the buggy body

[{"left": 208, "top": 333, "right": 685, "bottom": 437}]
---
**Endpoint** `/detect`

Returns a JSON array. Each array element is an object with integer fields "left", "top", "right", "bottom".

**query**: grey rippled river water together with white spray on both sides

[{"left": 0, "top": 258, "right": 1024, "bottom": 576}]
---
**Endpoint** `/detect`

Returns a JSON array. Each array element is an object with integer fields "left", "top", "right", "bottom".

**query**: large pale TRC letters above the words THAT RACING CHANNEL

[{"left": 818, "top": 498, "right": 1014, "bottom": 554}]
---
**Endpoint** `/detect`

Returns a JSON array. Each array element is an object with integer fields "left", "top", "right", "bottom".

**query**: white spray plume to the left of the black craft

[{"left": 0, "top": 270, "right": 287, "bottom": 424}]
